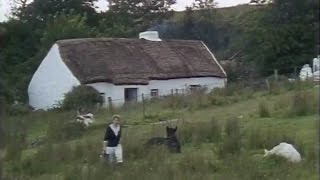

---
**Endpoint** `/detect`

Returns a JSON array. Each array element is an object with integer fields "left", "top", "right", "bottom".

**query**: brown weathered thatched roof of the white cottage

[{"left": 57, "top": 38, "right": 226, "bottom": 85}]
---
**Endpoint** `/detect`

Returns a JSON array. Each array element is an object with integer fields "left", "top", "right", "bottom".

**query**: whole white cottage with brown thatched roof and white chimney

[{"left": 28, "top": 32, "right": 227, "bottom": 109}]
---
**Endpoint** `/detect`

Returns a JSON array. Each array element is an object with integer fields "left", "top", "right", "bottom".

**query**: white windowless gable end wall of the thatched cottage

[{"left": 28, "top": 44, "right": 80, "bottom": 110}]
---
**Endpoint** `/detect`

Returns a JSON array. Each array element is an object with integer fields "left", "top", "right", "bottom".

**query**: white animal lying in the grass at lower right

[{"left": 264, "top": 142, "right": 301, "bottom": 163}]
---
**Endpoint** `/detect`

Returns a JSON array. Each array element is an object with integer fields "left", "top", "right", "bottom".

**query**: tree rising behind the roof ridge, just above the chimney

[{"left": 103, "top": 0, "right": 176, "bottom": 37}]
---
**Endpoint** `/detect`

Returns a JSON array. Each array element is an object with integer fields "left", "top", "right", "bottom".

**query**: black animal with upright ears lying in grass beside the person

[{"left": 145, "top": 126, "right": 181, "bottom": 153}]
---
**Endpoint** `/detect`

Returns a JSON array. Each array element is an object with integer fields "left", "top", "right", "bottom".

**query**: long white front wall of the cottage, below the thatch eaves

[{"left": 87, "top": 77, "right": 226, "bottom": 105}]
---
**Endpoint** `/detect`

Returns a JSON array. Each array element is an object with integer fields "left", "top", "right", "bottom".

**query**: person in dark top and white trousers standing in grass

[{"left": 102, "top": 115, "right": 123, "bottom": 163}]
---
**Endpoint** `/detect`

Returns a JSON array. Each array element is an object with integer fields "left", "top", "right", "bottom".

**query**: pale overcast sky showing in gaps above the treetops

[{"left": 0, "top": 0, "right": 250, "bottom": 22}]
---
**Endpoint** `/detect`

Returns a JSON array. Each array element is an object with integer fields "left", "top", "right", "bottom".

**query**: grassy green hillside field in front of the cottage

[{"left": 4, "top": 84, "right": 319, "bottom": 180}]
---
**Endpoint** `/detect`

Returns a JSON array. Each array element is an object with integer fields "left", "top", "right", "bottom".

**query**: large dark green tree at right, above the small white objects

[{"left": 243, "top": 0, "right": 319, "bottom": 74}]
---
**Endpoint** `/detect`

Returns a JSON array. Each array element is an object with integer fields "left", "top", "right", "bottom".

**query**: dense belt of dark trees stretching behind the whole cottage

[{"left": 0, "top": 0, "right": 319, "bottom": 102}]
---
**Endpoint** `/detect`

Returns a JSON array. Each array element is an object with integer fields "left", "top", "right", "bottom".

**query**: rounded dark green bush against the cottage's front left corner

[{"left": 62, "top": 86, "right": 104, "bottom": 110}]
